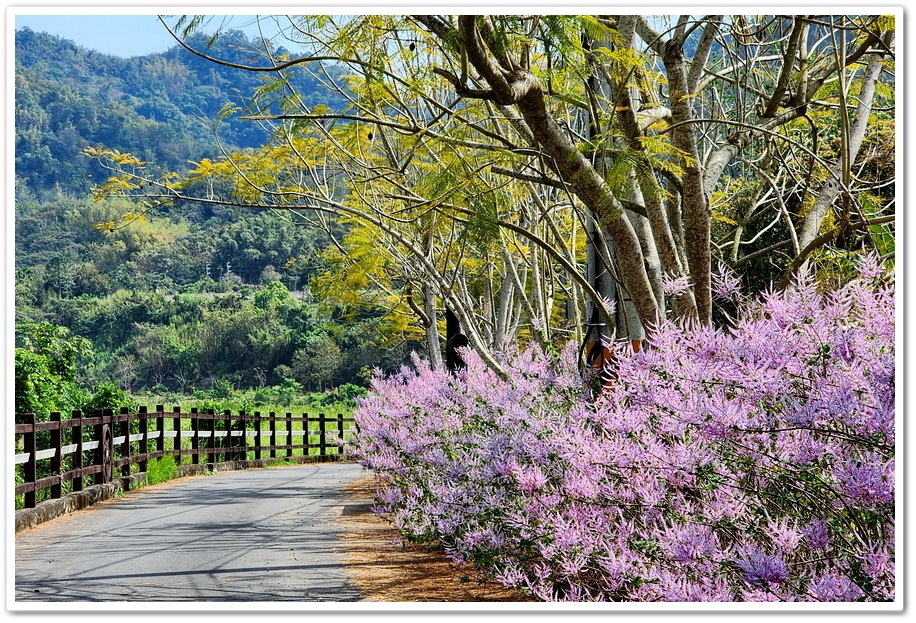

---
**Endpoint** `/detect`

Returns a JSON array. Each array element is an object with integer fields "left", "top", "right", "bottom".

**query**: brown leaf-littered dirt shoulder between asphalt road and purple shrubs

[{"left": 340, "top": 475, "right": 531, "bottom": 602}]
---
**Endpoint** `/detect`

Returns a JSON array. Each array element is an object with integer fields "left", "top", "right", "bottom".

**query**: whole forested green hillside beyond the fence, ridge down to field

[{"left": 15, "top": 29, "right": 410, "bottom": 420}]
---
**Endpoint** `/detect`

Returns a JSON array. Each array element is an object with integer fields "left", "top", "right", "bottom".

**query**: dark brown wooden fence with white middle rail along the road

[{"left": 14, "top": 405, "right": 355, "bottom": 508}]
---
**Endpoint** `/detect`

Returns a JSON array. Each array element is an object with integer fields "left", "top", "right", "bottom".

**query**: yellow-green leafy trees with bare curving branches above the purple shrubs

[{"left": 88, "top": 15, "right": 895, "bottom": 370}]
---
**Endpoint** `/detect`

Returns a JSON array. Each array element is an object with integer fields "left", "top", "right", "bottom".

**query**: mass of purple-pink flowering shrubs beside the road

[{"left": 353, "top": 262, "right": 895, "bottom": 601}]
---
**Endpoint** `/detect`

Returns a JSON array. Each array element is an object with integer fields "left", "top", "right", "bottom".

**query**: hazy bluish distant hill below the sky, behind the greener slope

[{"left": 15, "top": 28, "right": 343, "bottom": 197}]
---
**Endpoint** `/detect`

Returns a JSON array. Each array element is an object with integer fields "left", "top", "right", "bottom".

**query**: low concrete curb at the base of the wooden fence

[{"left": 16, "top": 454, "right": 352, "bottom": 532}]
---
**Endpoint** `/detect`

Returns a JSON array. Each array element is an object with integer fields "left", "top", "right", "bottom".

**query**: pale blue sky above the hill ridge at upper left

[{"left": 16, "top": 14, "right": 286, "bottom": 57}]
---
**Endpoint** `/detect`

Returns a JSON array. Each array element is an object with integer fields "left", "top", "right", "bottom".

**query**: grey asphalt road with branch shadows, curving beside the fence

[{"left": 15, "top": 463, "right": 366, "bottom": 602}]
